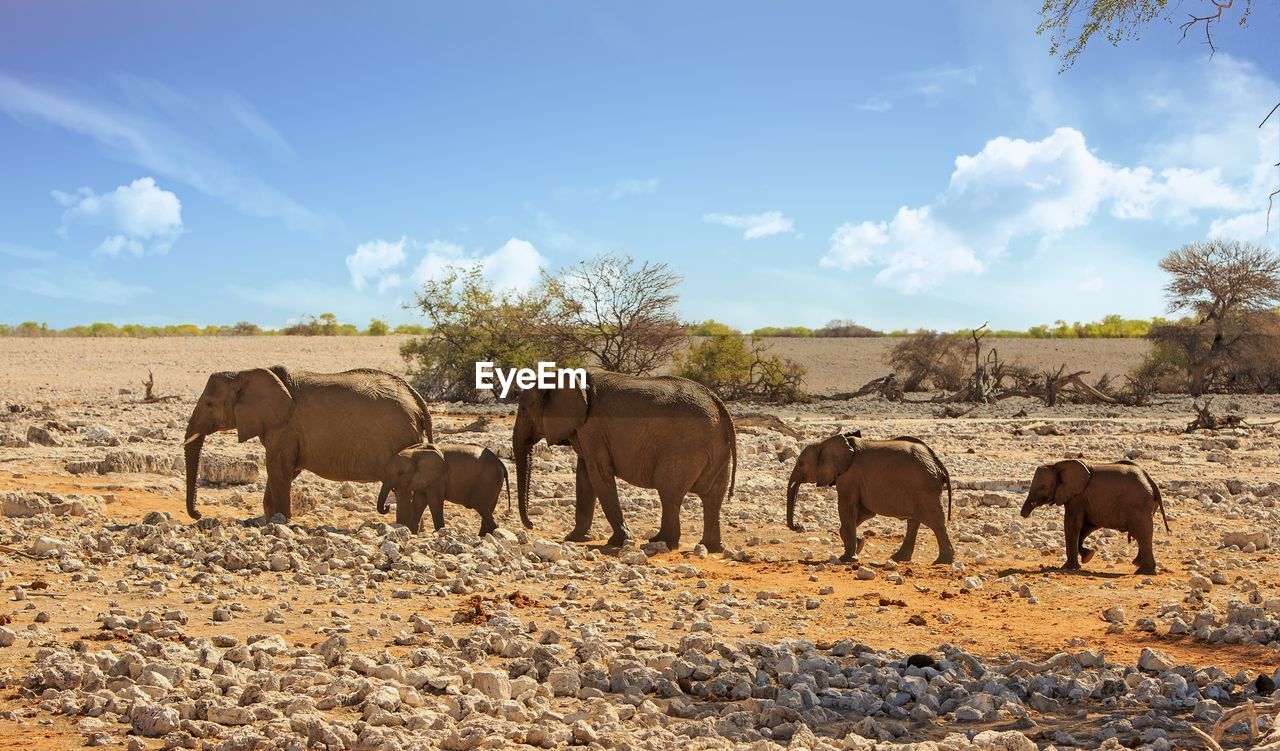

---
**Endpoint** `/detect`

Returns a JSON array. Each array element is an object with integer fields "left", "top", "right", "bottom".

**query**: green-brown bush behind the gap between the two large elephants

[{"left": 401, "top": 266, "right": 570, "bottom": 402}]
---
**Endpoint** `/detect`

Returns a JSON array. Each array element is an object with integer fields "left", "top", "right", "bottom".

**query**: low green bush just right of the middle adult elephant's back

[{"left": 675, "top": 334, "right": 806, "bottom": 403}]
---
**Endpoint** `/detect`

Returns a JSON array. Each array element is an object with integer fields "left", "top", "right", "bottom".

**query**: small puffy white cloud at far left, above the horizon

[{"left": 52, "top": 178, "right": 183, "bottom": 256}]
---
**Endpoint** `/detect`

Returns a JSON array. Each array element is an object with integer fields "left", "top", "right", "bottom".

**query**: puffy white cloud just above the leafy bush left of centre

[{"left": 347, "top": 237, "right": 547, "bottom": 293}]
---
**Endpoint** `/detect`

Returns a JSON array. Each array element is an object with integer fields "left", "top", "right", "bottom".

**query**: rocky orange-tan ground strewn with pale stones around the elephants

[{"left": 0, "top": 342, "right": 1280, "bottom": 750}]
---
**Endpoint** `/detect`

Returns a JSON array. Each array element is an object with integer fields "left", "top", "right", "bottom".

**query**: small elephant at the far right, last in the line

[{"left": 1021, "top": 459, "right": 1169, "bottom": 574}]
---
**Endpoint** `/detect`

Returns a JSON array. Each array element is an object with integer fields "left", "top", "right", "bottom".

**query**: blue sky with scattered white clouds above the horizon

[{"left": 0, "top": 0, "right": 1280, "bottom": 329}]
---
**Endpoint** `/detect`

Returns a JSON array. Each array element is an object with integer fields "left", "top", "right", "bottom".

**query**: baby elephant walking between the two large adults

[{"left": 378, "top": 444, "right": 511, "bottom": 536}]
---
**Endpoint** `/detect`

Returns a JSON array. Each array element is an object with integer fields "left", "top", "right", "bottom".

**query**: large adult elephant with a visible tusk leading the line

[{"left": 186, "top": 366, "right": 433, "bottom": 519}]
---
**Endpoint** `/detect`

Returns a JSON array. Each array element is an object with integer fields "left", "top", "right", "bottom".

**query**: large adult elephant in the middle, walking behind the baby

[{"left": 511, "top": 370, "right": 737, "bottom": 551}]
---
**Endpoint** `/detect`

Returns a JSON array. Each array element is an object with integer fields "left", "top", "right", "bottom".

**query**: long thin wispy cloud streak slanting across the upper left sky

[{"left": 0, "top": 73, "right": 330, "bottom": 232}]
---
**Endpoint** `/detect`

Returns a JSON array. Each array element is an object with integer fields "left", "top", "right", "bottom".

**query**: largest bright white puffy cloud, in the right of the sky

[{"left": 822, "top": 128, "right": 1264, "bottom": 294}]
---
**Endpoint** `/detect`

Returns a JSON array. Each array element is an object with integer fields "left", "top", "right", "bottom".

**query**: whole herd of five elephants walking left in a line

[{"left": 177, "top": 366, "right": 1169, "bottom": 573}]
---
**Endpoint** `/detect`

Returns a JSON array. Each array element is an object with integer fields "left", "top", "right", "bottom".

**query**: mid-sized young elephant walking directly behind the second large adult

[{"left": 787, "top": 431, "right": 955, "bottom": 563}]
